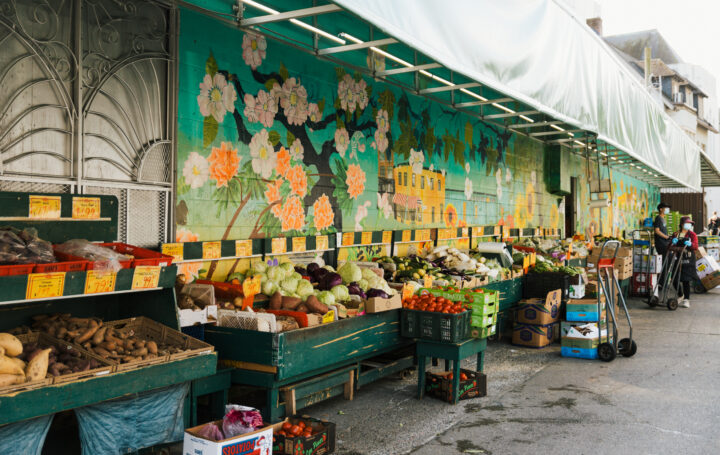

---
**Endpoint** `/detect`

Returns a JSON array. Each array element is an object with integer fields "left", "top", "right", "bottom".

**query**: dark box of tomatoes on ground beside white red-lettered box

[{"left": 272, "top": 415, "right": 336, "bottom": 455}]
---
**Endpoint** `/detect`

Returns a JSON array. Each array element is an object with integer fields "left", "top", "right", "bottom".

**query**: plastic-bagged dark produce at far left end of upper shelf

[{"left": 0, "top": 227, "right": 55, "bottom": 265}]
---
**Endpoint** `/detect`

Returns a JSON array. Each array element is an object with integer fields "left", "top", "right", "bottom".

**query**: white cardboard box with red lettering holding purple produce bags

[{"left": 183, "top": 420, "right": 282, "bottom": 455}]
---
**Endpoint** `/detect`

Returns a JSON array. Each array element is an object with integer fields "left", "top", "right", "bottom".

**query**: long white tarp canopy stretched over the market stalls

[{"left": 333, "top": 0, "right": 701, "bottom": 190}]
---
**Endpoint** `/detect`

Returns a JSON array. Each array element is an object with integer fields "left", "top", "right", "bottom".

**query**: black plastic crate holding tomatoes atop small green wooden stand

[{"left": 400, "top": 309, "right": 470, "bottom": 343}]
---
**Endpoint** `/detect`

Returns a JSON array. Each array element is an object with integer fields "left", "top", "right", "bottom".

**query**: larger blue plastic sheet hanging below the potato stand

[{"left": 75, "top": 382, "right": 190, "bottom": 455}]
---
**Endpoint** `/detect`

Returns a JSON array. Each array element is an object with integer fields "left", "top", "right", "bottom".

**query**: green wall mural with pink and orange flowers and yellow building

[{"left": 176, "top": 10, "right": 659, "bottom": 249}]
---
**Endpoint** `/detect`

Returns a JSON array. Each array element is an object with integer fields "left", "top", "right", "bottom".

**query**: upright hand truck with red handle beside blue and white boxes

[{"left": 597, "top": 240, "right": 637, "bottom": 362}]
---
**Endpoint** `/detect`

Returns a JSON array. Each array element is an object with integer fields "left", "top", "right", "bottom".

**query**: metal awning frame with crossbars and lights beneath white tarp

[{"left": 180, "top": 0, "right": 720, "bottom": 188}]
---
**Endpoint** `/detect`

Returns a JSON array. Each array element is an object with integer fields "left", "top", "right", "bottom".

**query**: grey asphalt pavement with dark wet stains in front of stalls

[{"left": 303, "top": 291, "right": 720, "bottom": 455}]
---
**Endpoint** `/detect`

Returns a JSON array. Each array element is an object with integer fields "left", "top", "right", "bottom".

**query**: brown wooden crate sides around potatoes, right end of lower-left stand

[{"left": 106, "top": 316, "right": 214, "bottom": 371}]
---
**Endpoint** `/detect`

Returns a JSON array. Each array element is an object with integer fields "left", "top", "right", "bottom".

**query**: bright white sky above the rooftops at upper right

[{"left": 596, "top": 0, "right": 720, "bottom": 93}]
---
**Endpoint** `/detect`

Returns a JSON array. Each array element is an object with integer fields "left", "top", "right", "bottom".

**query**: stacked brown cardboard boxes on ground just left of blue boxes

[{"left": 512, "top": 289, "right": 562, "bottom": 348}]
